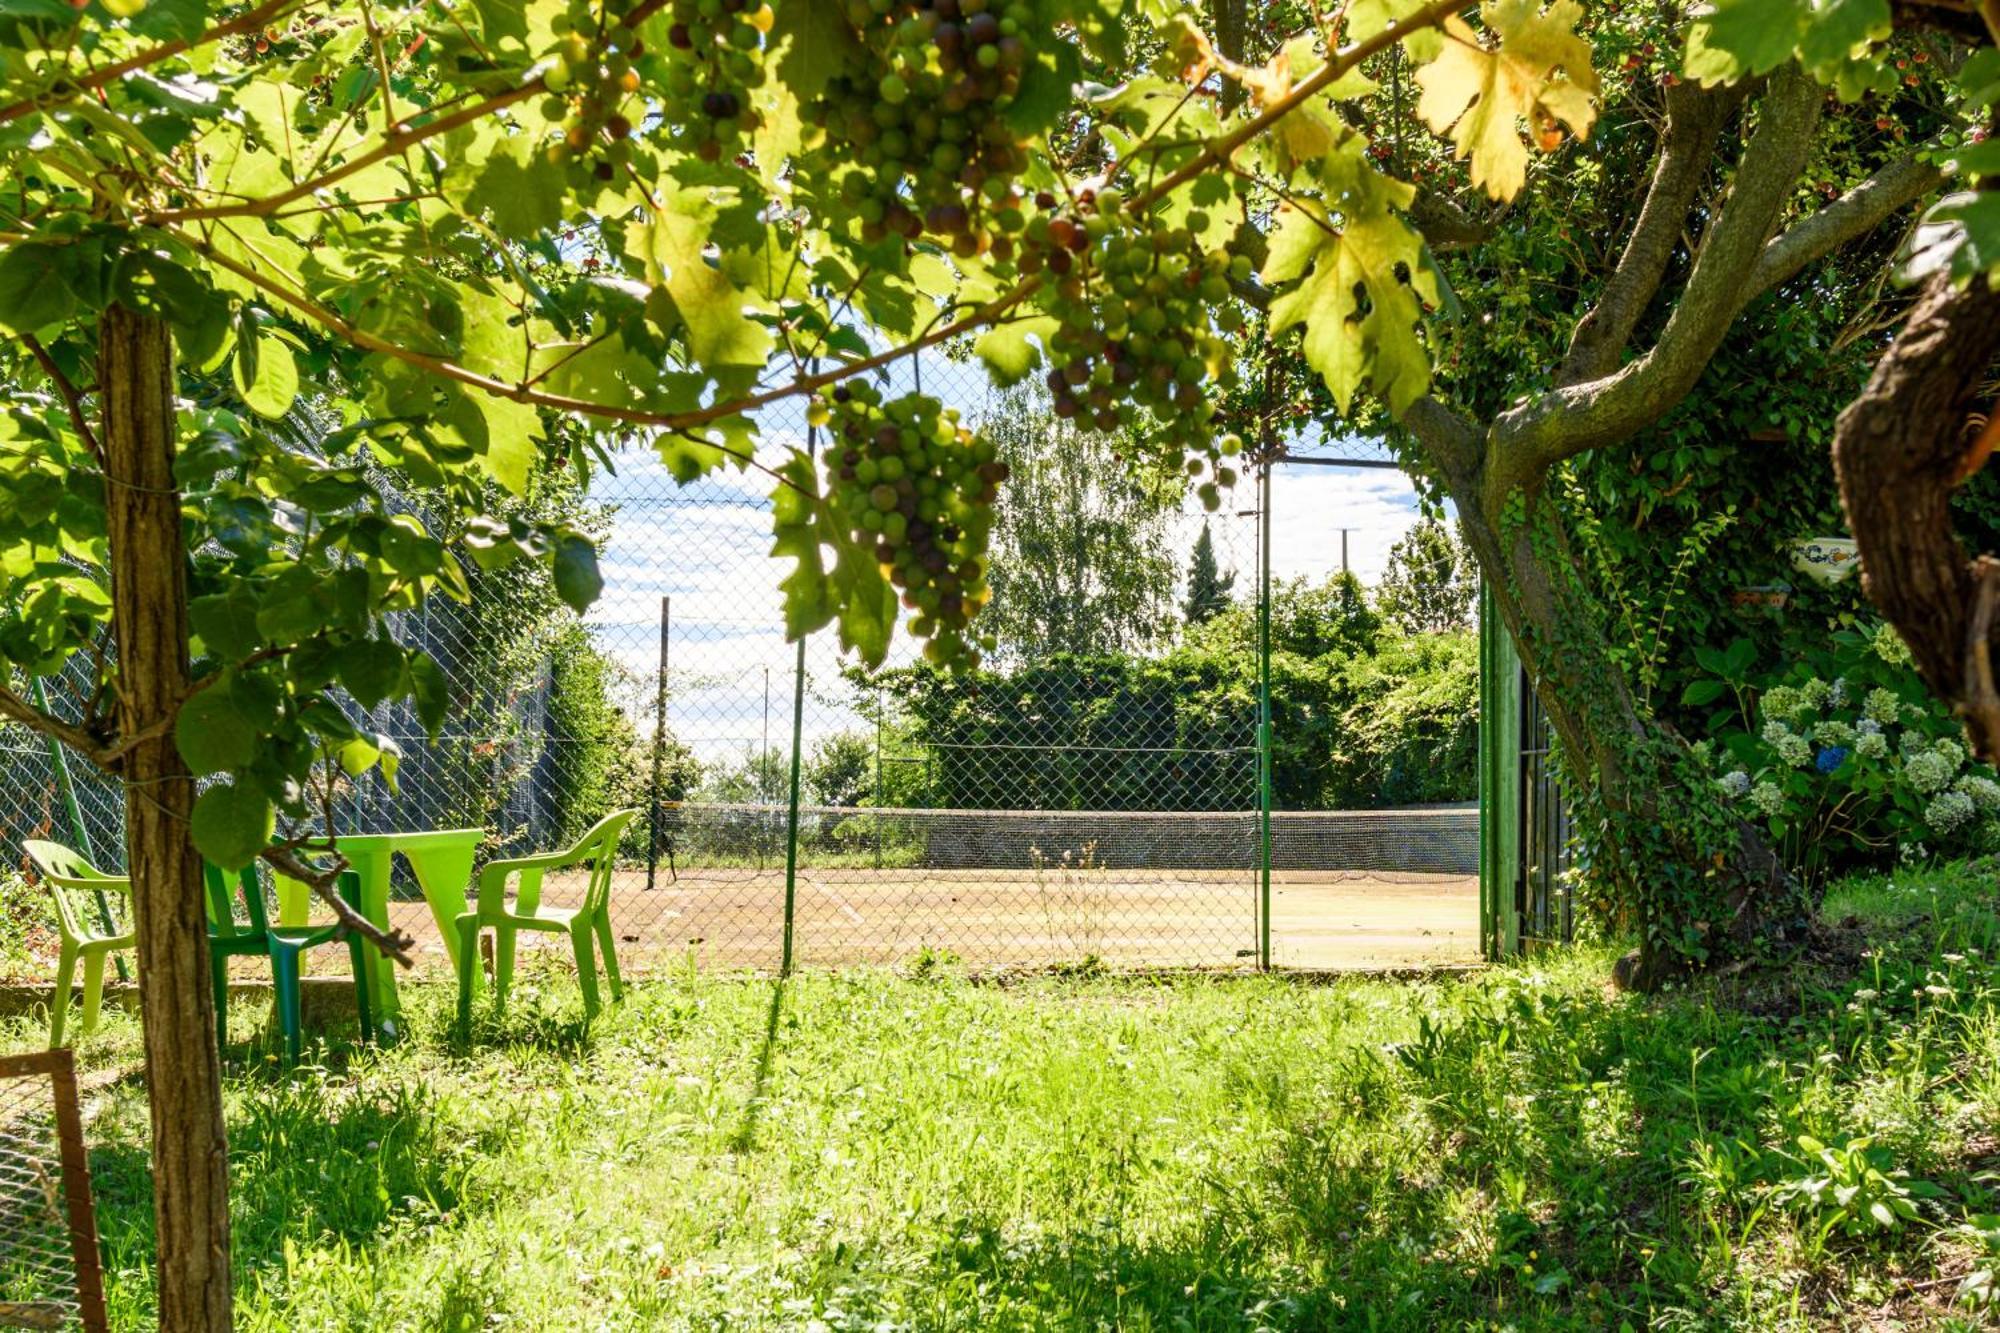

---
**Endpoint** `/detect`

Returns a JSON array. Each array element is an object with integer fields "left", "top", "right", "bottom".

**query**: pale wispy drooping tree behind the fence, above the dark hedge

[{"left": 980, "top": 388, "right": 1180, "bottom": 658}]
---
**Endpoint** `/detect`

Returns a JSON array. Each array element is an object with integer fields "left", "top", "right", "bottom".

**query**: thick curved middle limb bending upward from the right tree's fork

[{"left": 1488, "top": 66, "right": 1826, "bottom": 482}]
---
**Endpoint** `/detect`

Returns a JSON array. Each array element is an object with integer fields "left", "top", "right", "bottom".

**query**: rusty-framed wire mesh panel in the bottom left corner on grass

[{"left": 0, "top": 1051, "right": 106, "bottom": 1331}]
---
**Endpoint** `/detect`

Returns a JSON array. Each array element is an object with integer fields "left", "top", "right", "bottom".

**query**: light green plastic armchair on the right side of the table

[{"left": 454, "top": 809, "right": 638, "bottom": 1041}]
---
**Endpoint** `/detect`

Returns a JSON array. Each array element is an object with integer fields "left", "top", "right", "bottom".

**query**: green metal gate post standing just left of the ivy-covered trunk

[{"left": 1480, "top": 582, "right": 1522, "bottom": 961}]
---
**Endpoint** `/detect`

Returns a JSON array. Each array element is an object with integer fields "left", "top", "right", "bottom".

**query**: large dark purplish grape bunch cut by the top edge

[{"left": 806, "top": 0, "right": 1050, "bottom": 258}]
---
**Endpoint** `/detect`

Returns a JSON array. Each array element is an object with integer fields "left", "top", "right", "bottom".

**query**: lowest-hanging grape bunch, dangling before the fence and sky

[{"left": 808, "top": 380, "right": 1008, "bottom": 667}]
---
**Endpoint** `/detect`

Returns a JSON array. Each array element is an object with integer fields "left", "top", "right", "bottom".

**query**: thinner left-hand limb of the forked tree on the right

[{"left": 1556, "top": 82, "right": 1746, "bottom": 384}]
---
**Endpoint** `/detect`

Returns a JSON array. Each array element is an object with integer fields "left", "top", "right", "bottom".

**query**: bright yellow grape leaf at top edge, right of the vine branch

[{"left": 1416, "top": 0, "right": 1598, "bottom": 198}]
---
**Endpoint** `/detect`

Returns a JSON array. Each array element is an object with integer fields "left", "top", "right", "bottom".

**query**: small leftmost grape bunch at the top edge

[{"left": 542, "top": 0, "right": 646, "bottom": 184}]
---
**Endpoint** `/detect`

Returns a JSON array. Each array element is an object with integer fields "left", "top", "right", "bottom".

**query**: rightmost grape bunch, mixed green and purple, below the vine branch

[{"left": 1018, "top": 188, "right": 1250, "bottom": 508}]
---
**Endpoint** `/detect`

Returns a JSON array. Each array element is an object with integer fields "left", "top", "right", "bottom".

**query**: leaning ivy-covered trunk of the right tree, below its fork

[{"left": 1452, "top": 466, "right": 1804, "bottom": 991}]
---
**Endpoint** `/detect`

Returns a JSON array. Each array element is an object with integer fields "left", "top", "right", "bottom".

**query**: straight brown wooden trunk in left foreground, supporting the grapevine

[{"left": 98, "top": 304, "right": 230, "bottom": 1333}]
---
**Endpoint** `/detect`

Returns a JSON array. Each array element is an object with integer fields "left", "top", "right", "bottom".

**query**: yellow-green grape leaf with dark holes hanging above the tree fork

[{"left": 1262, "top": 136, "right": 1438, "bottom": 414}]
